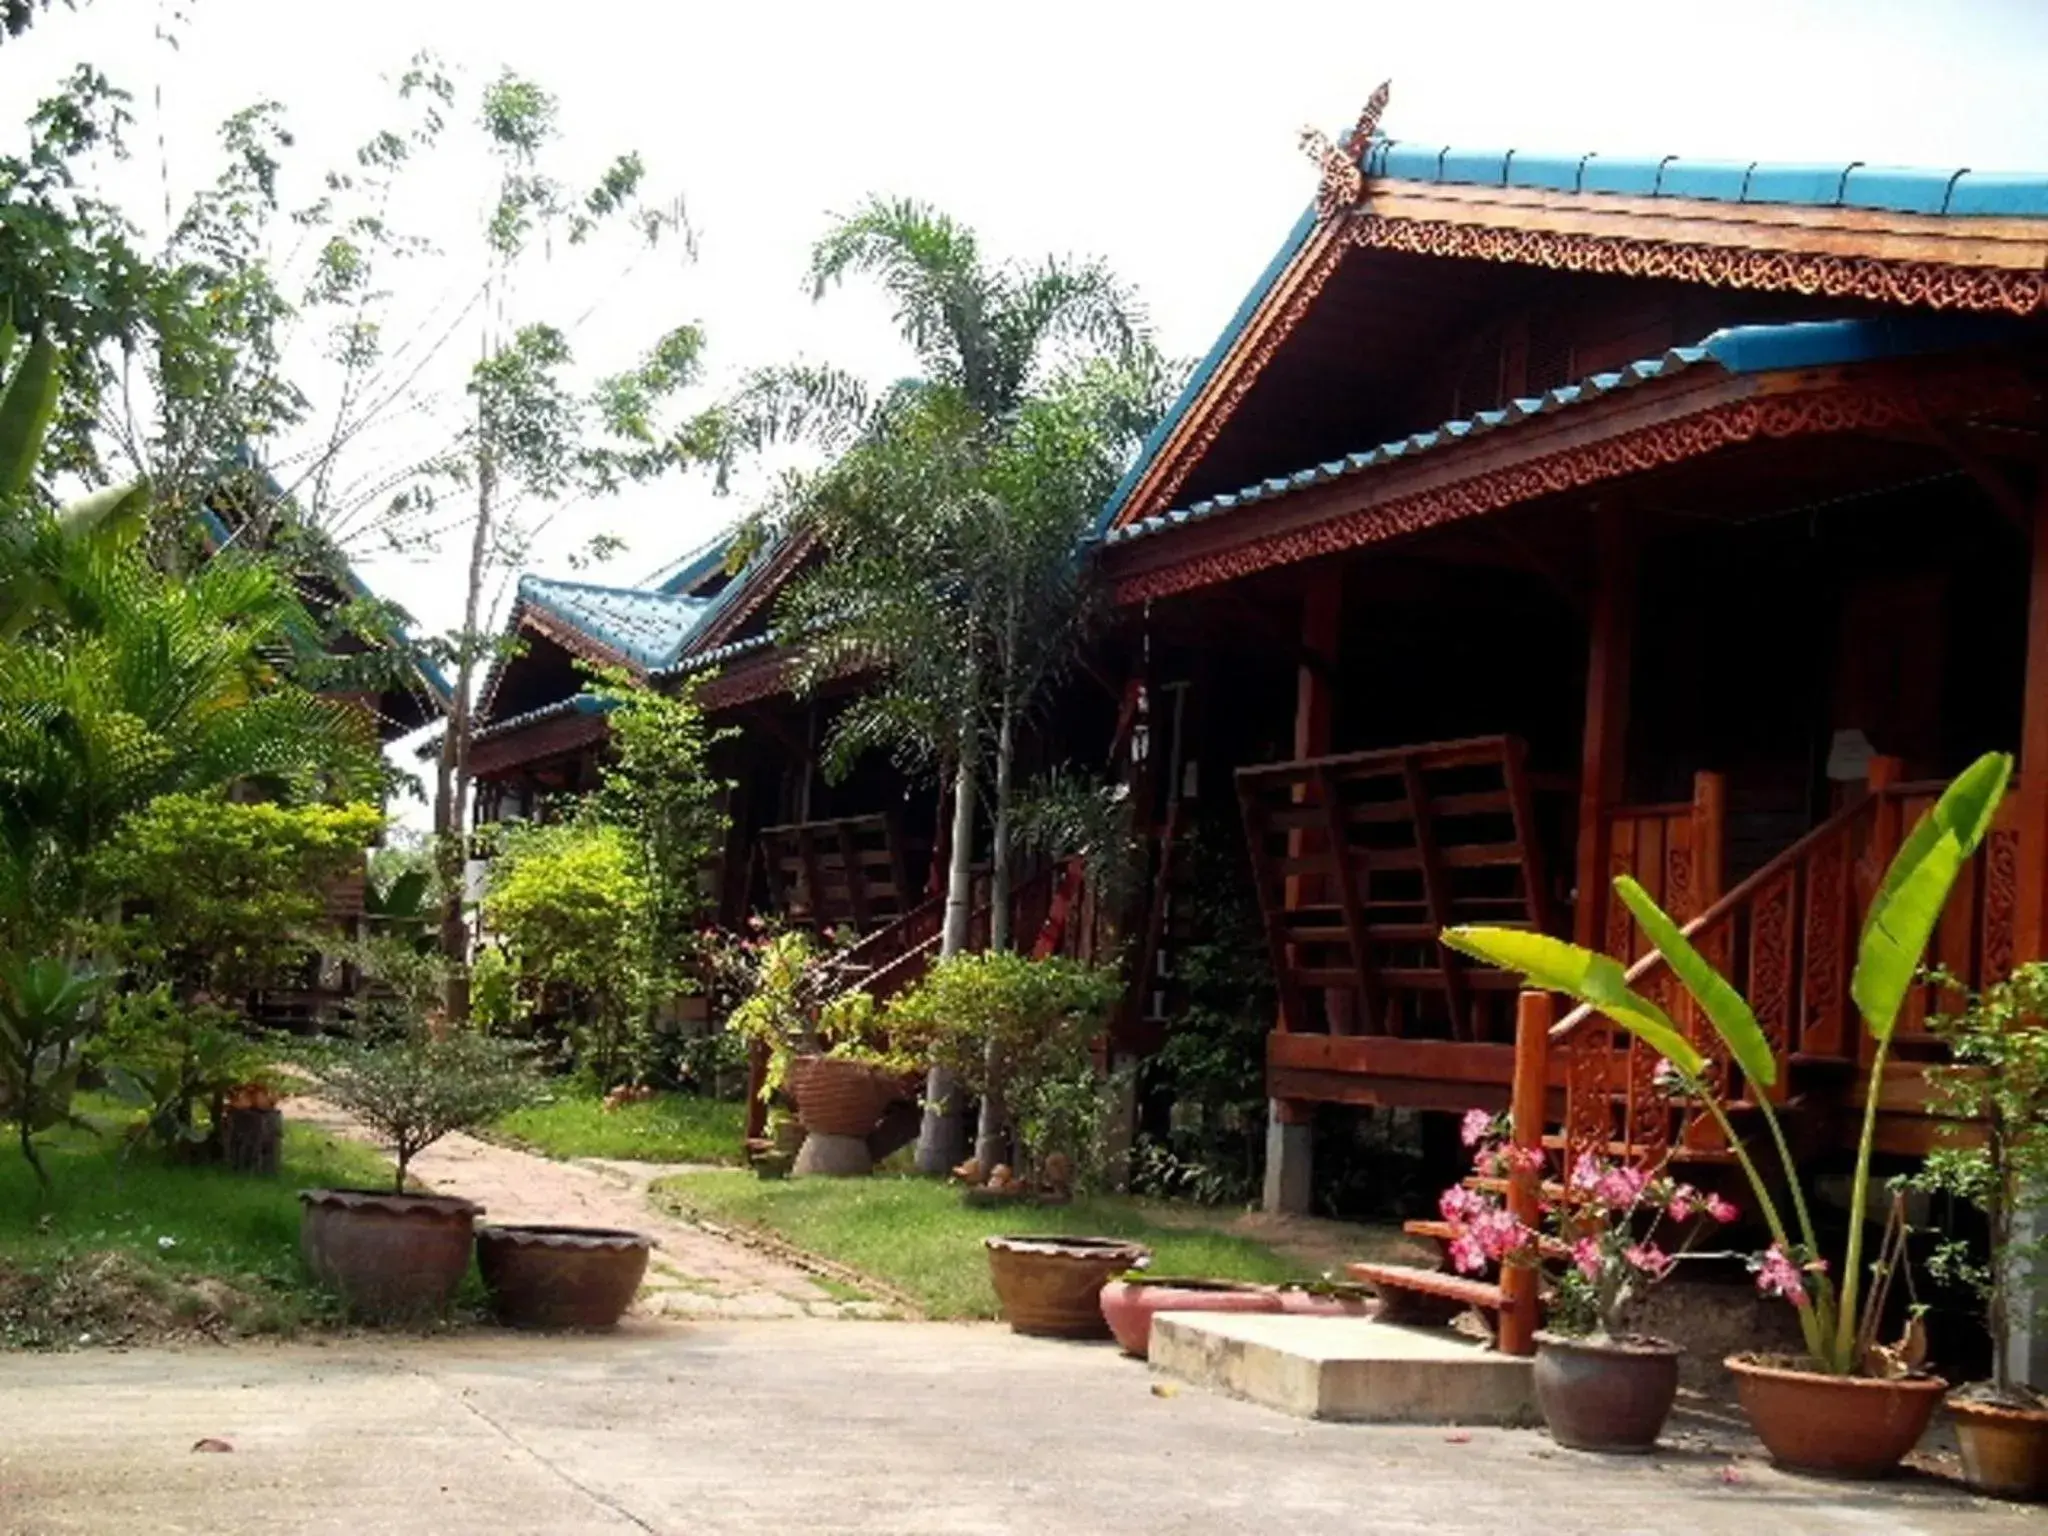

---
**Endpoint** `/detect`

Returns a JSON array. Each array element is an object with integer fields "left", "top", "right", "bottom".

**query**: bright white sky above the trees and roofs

[{"left": 0, "top": 0, "right": 2048, "bottom": 647}]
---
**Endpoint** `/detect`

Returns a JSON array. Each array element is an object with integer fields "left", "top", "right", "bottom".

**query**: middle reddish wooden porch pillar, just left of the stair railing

[{"left": 1571, "top": 508, "right": 1636, "bottom": 948}]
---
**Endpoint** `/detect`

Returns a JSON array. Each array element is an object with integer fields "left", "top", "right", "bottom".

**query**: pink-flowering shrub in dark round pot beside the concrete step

[{"left": 1440, "top": 1110, "right": 1735, "bottom": 1452}]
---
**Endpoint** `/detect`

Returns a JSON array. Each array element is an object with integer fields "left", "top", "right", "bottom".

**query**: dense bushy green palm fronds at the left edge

[{"left": 0, "top": 338, "right": 383, "bottom": 948}]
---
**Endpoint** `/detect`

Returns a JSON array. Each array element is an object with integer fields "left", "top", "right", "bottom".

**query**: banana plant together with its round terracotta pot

[{"left": 1444, "top": 752, "right": 2013, "bottom": 1477}]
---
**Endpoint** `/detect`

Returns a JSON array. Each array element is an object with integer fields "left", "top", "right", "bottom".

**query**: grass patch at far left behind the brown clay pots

[{"left": 0, "top": 1096, "right": 389, "bottom": 1348}]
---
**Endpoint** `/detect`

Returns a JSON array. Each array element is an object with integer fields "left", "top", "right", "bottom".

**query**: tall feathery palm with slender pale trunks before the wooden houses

[{"left": 713, "top": 199, "right": 1169, "bottom": 1174}]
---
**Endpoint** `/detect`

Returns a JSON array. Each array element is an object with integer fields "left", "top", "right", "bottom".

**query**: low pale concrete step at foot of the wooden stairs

[{"left": 1151, "top": 1313, "right": 1536, "bottom": 1423}]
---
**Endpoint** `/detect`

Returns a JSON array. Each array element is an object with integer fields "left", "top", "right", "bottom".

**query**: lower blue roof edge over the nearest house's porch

[{"left": 1104, "top": 315, "right": 2025, "bottom": 545}]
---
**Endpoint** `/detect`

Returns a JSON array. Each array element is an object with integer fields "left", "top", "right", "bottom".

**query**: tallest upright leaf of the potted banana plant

[{"left": 1849, "top": 752, "right": 2013, "bottom": 1040}]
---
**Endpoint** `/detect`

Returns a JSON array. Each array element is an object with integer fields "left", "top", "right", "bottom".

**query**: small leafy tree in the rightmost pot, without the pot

[{"left": 1913, "top": 961, "right": 2048, "bottom": 1405}]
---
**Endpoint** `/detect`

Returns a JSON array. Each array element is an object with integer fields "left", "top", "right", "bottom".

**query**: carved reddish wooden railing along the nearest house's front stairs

[{"left": 1544, "top": 760, "right": 2017, "bottom": 1167}]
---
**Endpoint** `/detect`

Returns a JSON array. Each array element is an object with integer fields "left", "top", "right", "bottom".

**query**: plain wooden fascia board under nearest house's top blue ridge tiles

[{"left": 1360, "top": 178, "right": 2048, "bottom": 272}]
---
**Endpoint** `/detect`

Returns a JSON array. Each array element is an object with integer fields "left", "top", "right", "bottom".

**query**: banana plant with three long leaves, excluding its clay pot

[{"left": 1444, "top": 752, "right": 2013, "bottom": 1376}]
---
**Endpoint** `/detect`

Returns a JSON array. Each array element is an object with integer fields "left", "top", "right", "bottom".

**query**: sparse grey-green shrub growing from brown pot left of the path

[{"left": 315, "top": 1028, "right": 539, "bottom": 1192}]
